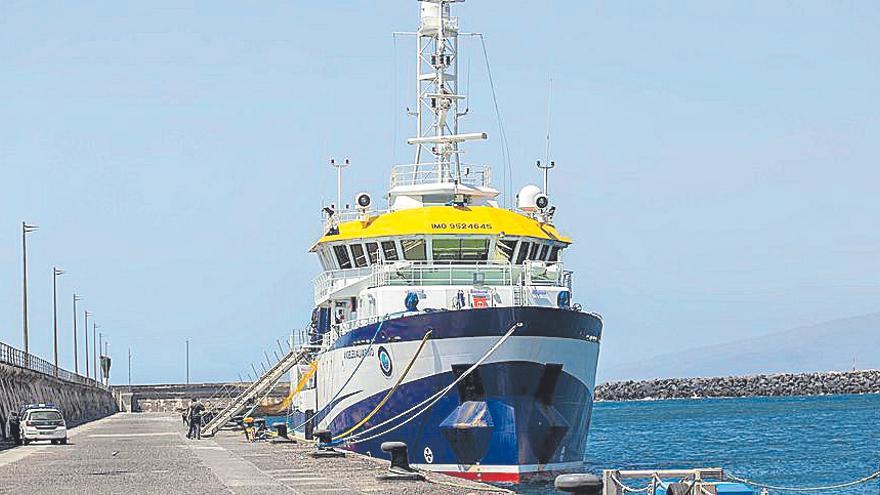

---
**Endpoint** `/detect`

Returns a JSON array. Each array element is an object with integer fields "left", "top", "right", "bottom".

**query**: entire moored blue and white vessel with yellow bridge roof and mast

[{"left": 288, "top": 0, "right": 602, "bottom": 483}]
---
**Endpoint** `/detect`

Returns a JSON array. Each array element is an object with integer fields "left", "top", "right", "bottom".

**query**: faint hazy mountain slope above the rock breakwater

[{"left": 599, "top": 313, "right": 880, "bottom": 382}]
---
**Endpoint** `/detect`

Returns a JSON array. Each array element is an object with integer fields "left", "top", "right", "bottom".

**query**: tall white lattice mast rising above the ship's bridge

[{"left": 407, "top": 0, "right": 486, "bottom": 183}]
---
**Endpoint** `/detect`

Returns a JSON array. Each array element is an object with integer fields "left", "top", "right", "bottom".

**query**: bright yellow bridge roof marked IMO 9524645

[{"left": 318, "top": 206, "right": 571, "bottom": 244}]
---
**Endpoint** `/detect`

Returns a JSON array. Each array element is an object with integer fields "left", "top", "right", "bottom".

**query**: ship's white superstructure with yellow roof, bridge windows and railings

[{"left": 312, "top": 205, "right": 571, "bottom": 336}]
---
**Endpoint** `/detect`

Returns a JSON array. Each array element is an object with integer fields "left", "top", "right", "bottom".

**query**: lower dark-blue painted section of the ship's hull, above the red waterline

[{"left": 330, "top": 362, "right": 593, "bottom": 465}]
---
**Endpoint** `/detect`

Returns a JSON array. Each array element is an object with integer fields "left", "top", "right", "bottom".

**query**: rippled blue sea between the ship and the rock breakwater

[{"left": 525, "top": 395, "right": 880, "bottom": 495}]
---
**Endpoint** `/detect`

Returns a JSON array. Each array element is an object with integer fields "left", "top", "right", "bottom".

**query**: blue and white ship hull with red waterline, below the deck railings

[{"left": 294, "top": 307, "right": 602, "bottom": 483}]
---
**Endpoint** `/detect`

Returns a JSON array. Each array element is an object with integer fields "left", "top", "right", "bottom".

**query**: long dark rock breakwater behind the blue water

[{"left": 595, "top": 370, "right": 880, "bottom": 401}]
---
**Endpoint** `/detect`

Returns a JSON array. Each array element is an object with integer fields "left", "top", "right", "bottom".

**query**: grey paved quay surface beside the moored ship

[{"left": 0, "top": 413, "right": 505, "bottom": 495}]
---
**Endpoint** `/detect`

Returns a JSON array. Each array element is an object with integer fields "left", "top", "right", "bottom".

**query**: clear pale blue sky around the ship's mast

[{"left": 0, "top": 0, "right": 880, "bottom": 383}]
